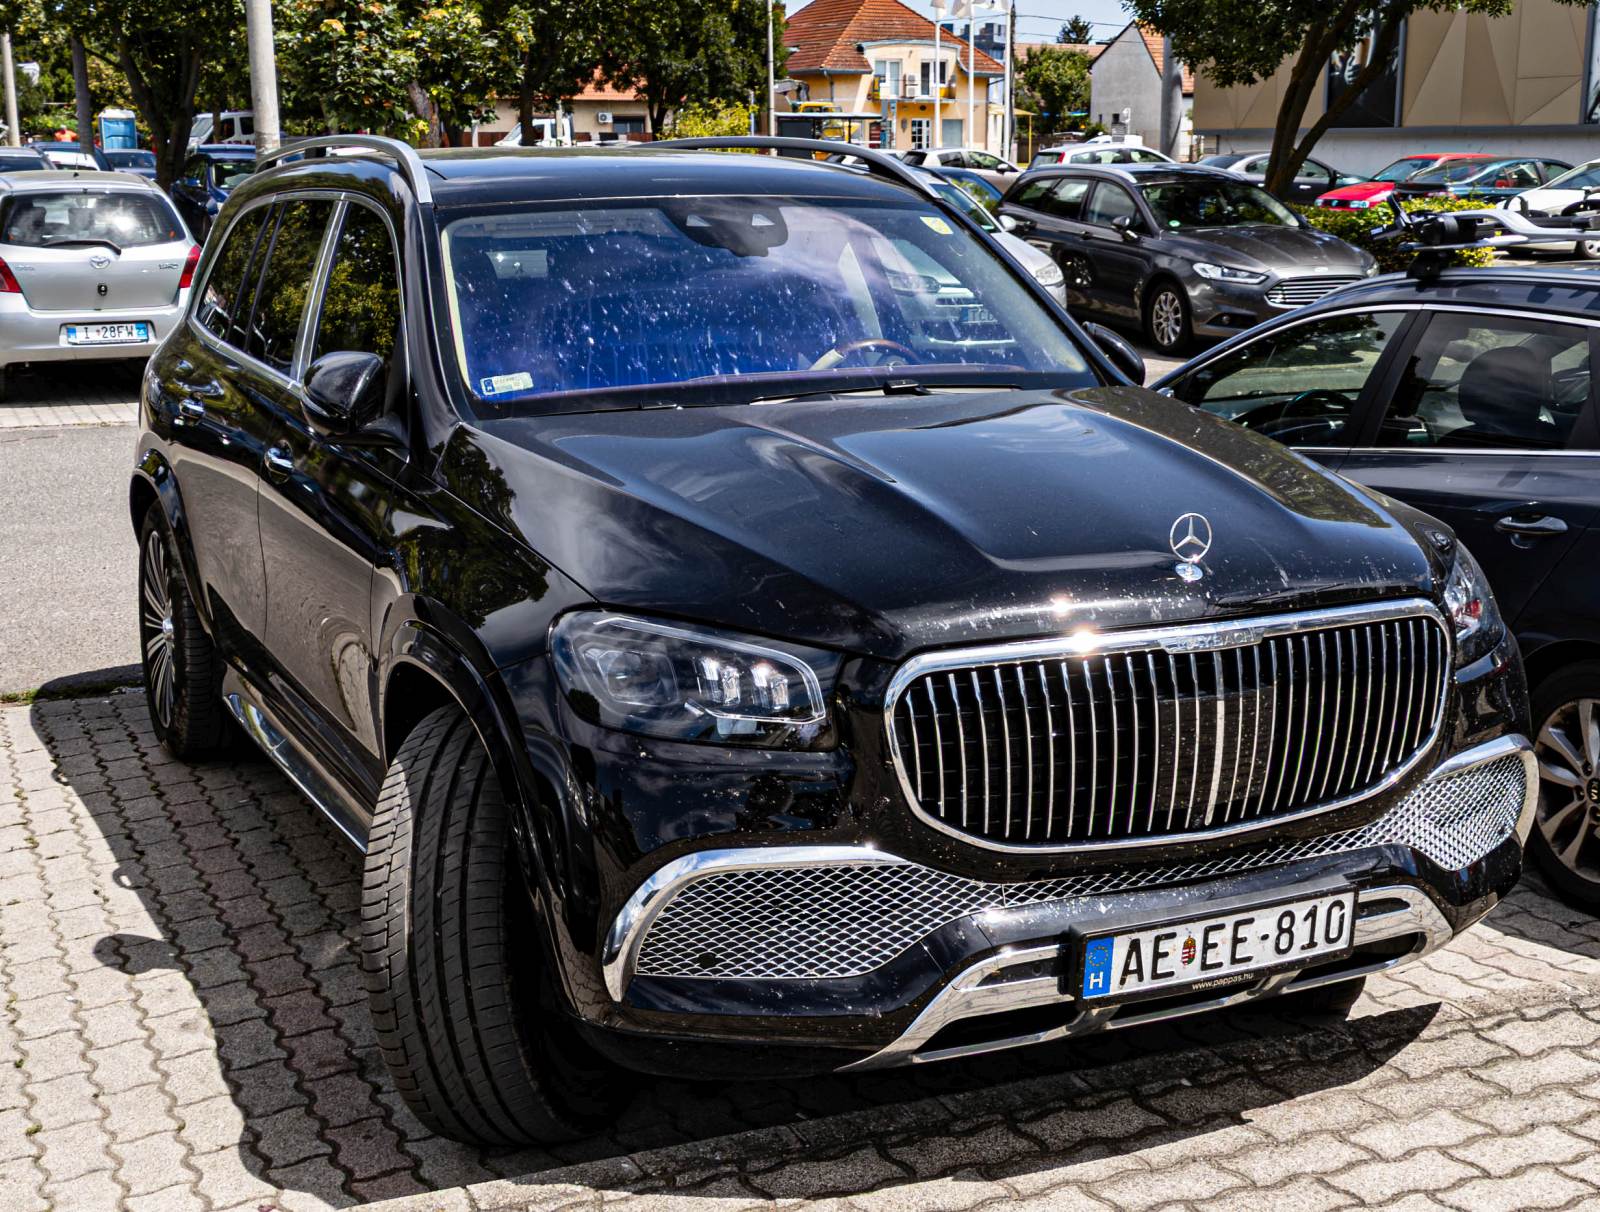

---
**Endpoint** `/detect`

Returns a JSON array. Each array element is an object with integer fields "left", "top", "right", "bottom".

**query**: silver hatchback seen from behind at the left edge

[{"left": 0, "top": 171, "right": 200, "bottom": 392}]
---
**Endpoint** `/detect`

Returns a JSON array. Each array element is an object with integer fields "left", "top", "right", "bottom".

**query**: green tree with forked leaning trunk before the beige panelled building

[{"left": 1128, "top": 0, "right": 1587, "bottom": 189}]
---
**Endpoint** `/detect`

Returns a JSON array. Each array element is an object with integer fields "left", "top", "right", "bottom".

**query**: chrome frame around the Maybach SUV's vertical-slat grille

[{"left": 883, "top": 598, "right": 1456, "bottom": 854}]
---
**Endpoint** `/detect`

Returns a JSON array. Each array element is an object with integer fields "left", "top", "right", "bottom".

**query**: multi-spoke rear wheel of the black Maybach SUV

[{"left": 139, "top": 502, "right": 229, "bottom": 761}]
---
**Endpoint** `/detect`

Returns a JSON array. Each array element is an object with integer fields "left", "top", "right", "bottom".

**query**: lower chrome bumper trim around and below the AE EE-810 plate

[{"left": 840, "top": 886, "right": 1453, "bottom": 1073}]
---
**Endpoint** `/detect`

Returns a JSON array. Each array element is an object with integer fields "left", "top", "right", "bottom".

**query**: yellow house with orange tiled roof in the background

[{"left": 784, "top": 0, "right": 1005, "bottom": 153}]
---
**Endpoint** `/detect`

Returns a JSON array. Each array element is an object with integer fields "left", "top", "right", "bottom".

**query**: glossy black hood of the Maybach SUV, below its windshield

[{"left": 442, "top": 387, "right": 1434, "bottom": 659}]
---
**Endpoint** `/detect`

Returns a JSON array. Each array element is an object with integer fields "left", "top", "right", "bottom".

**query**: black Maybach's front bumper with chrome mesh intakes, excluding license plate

[{"left": 590, "top": 736, "right": 1538, "bottom": 1071}]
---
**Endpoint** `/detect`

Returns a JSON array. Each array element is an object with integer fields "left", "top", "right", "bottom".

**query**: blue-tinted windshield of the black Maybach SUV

[{"left": 443, "top": 197, "right": 1096, "bottom": 413}]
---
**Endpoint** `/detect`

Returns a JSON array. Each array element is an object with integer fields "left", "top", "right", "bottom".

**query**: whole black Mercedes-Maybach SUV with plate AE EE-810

[{"left": 130, "top": 136, "right": 1534, "bottom": 1143}]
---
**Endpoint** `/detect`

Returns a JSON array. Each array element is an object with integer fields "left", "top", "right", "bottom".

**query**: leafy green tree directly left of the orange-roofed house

[{"left": 603, "top": 0, "right": 787, "bottom": 131}]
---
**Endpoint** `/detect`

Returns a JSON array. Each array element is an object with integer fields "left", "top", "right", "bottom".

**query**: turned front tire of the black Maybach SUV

[{"left": 362, "top": 707, "right": 622, "bottom": 1146}]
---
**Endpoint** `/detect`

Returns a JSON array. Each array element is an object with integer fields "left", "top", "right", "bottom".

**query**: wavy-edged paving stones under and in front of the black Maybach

[{"left": 0, "top": 694, "right": 1600, "bottom": 1212}]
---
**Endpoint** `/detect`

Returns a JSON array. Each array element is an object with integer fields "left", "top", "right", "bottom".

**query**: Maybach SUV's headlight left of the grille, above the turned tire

[{"left": 550, "top": 611, "right": 827, "bottom": 748}]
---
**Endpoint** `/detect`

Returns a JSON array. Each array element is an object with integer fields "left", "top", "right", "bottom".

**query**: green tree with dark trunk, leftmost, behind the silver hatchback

[{"left": 53, "top": 0, "right": 245, "bottom": 185}]
